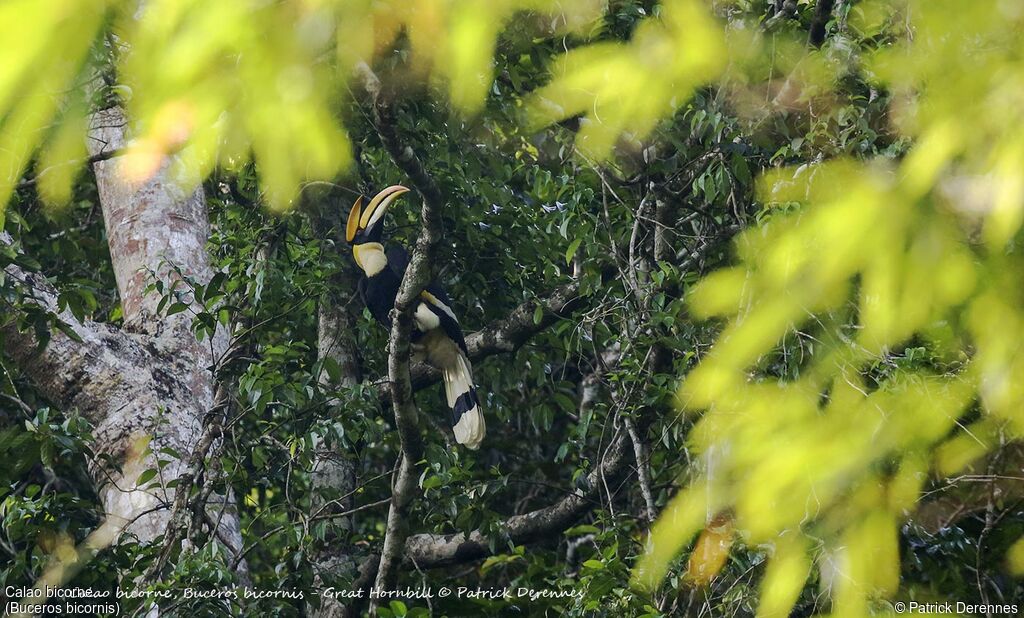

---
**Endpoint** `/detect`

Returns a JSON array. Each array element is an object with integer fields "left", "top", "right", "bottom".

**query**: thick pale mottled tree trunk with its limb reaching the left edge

[{"left": 3, "top": 108, "right": 241, "bottom": 564}]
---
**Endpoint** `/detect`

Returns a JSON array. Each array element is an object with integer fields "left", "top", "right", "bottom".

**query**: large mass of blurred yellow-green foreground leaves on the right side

[{"left": 636, "top": 1, "right": 1024, "bottom": 615}]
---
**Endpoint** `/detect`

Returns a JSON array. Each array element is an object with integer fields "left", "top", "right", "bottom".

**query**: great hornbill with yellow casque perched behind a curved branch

[{"left": 345, "top": 185, "right": 486, "bottom": 449}]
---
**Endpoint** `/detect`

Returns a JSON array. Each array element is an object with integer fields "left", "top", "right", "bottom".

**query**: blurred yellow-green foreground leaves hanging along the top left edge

[{"left": 0, "top": 0, "right": 601, "bottom": 214}]
